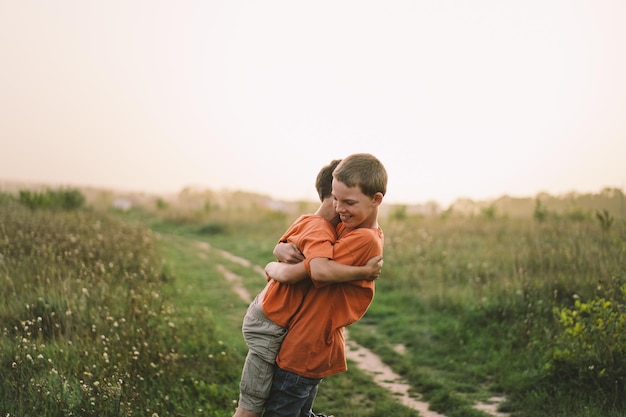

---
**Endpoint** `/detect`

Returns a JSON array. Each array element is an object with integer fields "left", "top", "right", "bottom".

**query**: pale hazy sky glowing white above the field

[{"left": 0, "top": 0, "right": 626, "bottom": 204}]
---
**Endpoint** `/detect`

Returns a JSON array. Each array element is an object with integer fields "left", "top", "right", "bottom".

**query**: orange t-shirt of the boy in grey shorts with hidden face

[{"left": 262, "top": 214, "right": 337, "bottom": 327}]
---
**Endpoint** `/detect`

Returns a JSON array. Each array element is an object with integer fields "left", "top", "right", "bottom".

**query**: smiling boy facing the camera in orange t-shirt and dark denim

[{"left": 263, "top": 154, "right": 387, "bottom": 417}]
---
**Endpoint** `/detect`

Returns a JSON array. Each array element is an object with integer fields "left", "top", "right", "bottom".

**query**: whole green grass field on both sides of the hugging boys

[{"left": 0, "top": 189, "right": 626, "bottom": 417}]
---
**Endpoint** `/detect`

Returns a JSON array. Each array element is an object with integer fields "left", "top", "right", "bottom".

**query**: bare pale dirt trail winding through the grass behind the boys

[{"left": 197, "top": 242, "right": 508, "bottom": 417}]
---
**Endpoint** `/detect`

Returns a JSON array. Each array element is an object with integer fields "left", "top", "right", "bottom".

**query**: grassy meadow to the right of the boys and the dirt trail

[{"left": 352, "top": 216, "right": 626, "bottom": 416}]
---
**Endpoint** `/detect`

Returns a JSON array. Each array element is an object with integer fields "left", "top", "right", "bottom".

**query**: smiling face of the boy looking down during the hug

[{"left": 333, "top": 179, "right": 382, "bottom": 229}]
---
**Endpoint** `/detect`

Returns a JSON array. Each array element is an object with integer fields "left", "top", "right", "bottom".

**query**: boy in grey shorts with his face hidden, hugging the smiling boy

[{"left": 233, "top": 160, "right": 382, "bottom": 417}]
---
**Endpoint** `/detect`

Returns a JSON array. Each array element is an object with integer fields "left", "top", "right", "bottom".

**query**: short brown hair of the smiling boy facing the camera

[{"left": 333, "top": 153, "right": 387, "bottom": 197}]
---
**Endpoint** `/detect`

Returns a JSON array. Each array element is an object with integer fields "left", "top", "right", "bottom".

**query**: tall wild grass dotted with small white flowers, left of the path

[{"left": 0, "top": 199, "right": 240, "bottom": 416}]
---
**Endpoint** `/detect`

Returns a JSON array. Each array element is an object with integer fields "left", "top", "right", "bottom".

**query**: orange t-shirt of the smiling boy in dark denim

[{"left": 276, "top": 224, "right": 384, "bottom": 378}]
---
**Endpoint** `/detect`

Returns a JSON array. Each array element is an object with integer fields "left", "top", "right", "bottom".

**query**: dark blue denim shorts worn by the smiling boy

[{"left": 263, "top": 366, "right": 322, "bottom": 417}]
